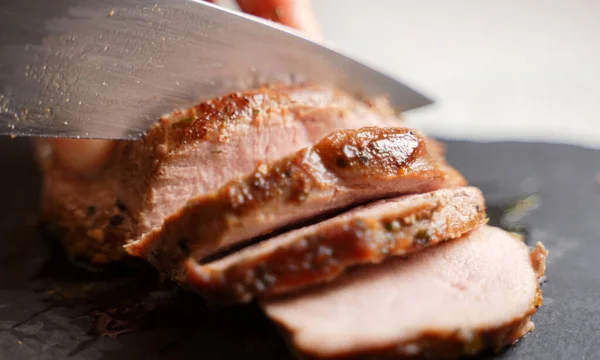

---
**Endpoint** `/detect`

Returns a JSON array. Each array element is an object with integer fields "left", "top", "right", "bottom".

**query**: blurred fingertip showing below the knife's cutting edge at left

[{"left": 48, "top": 139, "right": 114, "bottom": 175}]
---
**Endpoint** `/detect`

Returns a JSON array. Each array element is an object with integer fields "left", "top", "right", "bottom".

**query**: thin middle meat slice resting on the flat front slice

[{"left": 186, "top": 187, "right": 486, "bottom": 302}]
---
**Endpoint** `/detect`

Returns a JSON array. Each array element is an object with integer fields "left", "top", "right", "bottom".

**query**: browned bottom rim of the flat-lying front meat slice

[{"left": 275, "top": 242, "right": 548, "bottom": 360}]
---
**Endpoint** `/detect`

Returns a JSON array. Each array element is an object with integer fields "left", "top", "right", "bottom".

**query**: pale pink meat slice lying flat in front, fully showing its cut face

[{"left": 262, "top": 226, "right": 546, "bottom": 359}]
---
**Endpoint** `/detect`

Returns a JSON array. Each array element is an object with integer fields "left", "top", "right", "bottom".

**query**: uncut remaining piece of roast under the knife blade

[{"left": 37, "top": 85, "right": 401, "bottom": 263}]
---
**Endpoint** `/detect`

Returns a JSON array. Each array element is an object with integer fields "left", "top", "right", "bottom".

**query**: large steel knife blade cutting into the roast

[{"left": 0, "top": 0, "right": 431, "bottom": 139}]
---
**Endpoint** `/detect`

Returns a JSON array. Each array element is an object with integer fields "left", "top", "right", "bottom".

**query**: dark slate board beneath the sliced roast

[{"left": 0, "top": 136, "right": 600, "bottom": 360}]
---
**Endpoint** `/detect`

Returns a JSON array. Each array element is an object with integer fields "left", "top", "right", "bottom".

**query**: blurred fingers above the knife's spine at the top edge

[{"left": 237, "top": 0, "right": 321, "bottom": 40}]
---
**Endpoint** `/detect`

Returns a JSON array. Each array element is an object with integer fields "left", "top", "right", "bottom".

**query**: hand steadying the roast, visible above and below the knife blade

[{"left": 47, "top": 0, "right": 320, "bottom": 174}]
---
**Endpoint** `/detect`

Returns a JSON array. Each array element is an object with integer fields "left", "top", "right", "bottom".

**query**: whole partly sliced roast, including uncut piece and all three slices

[{"left": 37, "top": 81, "right": 547, "bottom": 359}]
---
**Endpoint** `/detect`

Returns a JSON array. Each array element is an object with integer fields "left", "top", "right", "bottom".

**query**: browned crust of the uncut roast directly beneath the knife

[{"left": 36, "top": 84, "right": 400, "bottom": 264}]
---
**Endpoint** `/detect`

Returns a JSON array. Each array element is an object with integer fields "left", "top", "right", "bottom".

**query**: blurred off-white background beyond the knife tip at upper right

[{"left": 221, "top": 0, "right": 600, "bottom": 148}]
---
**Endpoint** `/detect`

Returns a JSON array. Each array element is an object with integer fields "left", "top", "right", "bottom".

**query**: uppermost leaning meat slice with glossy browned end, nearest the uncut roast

[{"left": 127, "top": 127, "right": 454, "bottom": 277}]
